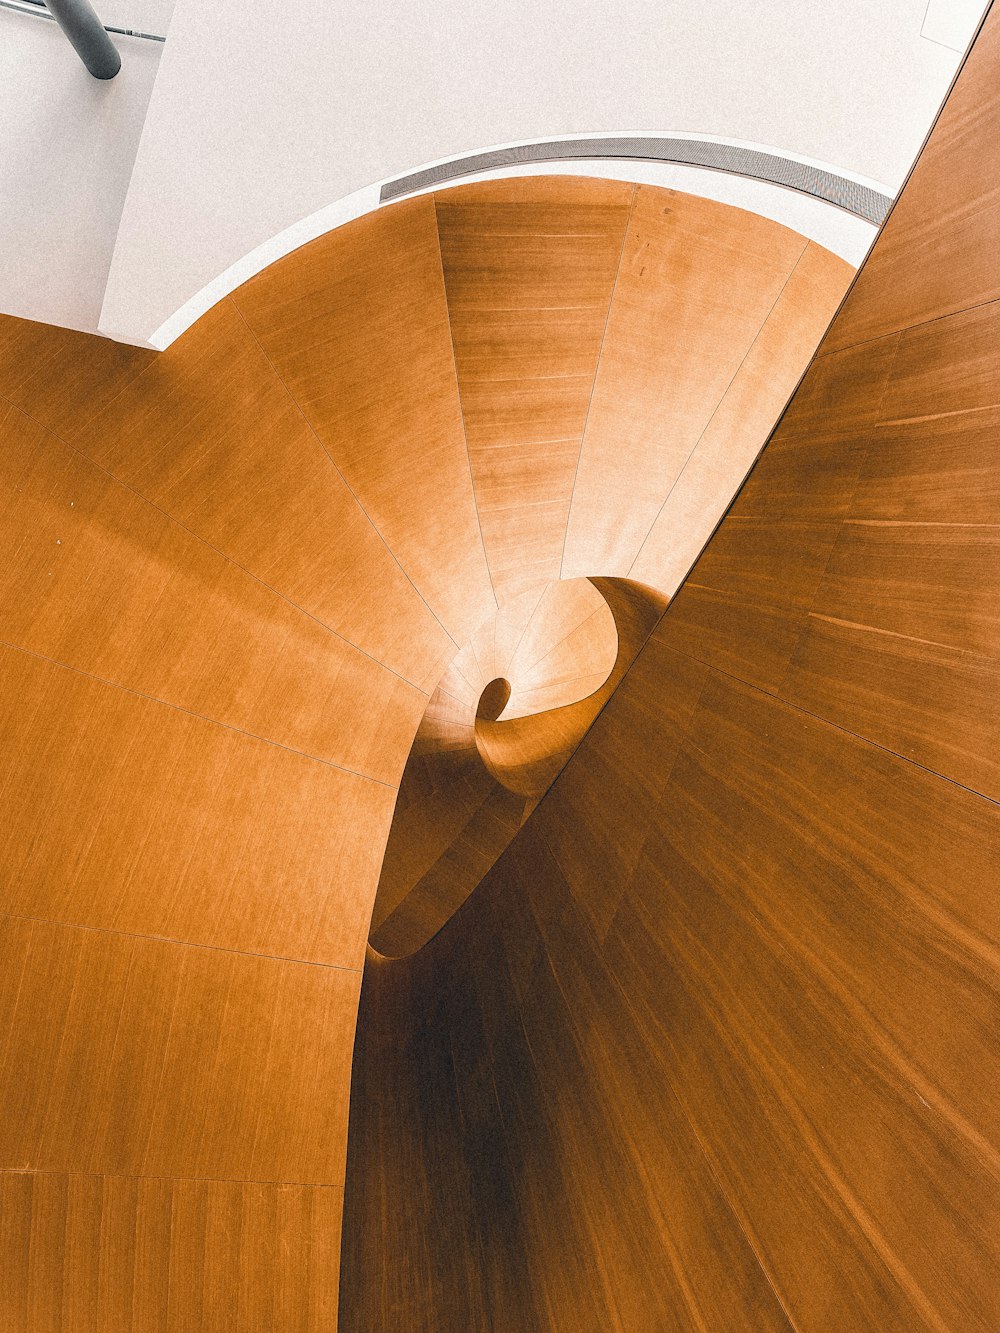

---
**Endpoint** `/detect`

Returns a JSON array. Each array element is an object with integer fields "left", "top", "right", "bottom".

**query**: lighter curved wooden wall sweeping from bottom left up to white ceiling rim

[{"left": 0, "top": 180, "right": 849, "bottom": 1333}]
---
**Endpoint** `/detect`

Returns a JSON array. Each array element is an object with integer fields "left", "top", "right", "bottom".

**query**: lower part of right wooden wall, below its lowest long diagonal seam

[{"left": 341, "top": 619, "right": 1000, "bottom": 1333}]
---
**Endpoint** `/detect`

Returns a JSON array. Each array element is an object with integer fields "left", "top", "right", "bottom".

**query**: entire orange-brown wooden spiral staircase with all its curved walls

[{"left": 0, "top": 7, "right": 1000, "bottom": 1333}]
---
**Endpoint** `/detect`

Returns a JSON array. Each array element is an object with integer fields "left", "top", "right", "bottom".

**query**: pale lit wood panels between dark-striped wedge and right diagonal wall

[{"left": 563, "top": 185, "right": 851, "bottom": 593}]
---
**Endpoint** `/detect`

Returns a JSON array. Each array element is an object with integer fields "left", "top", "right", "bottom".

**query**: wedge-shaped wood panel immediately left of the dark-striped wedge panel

[{"left": 232, "top": 197, "right": 495, "bottom": 647}]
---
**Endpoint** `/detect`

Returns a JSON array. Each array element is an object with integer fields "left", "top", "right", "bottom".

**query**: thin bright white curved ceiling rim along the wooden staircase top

[{"left": 137, "top": 131, "right": 892, "bottom": 352}]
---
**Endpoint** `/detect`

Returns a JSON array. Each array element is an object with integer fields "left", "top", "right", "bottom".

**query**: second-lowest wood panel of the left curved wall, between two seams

[{"left": 0, "top": 917, "right": 360, "bottom": 1188}]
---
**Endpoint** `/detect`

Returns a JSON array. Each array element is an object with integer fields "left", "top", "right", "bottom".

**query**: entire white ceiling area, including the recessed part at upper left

[{"left": 0, "top": 0, "right": 984, "bottom": 343}]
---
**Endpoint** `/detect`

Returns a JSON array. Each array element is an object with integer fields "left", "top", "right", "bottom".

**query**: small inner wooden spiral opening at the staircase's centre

[{"left": 371, "top": 579, "right": 665, "bottom": 957}]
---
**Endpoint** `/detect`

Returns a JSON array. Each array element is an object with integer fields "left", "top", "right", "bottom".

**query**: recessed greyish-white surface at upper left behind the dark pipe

[{"left": 0, "top": 0, "right": 167, "bottom": 332}]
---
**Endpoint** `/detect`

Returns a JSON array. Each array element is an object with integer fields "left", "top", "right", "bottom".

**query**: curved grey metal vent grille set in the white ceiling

[{"left": 380, "top": 137, "right": 892, "bottom": 225}]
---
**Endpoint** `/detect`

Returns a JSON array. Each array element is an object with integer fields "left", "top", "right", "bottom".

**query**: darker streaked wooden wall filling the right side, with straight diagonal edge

[{"left": 341, "top": 12, "right": 1000, "bottom": 1333}]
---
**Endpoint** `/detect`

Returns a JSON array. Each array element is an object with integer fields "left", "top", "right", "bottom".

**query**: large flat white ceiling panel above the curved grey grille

[{"left": 101, "top": 0, "right": 981, "bottom": 343}]
